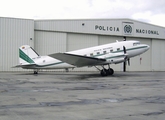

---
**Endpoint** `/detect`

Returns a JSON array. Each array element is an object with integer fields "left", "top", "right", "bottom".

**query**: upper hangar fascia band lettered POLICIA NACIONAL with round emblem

[{"left": 35, "top": 19, "right": 165, "bottom": 39}]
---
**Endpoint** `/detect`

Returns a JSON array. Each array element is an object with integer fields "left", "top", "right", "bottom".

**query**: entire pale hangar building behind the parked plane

[{"left": 0, "top": 17, "right": 165, "bottom": 71}]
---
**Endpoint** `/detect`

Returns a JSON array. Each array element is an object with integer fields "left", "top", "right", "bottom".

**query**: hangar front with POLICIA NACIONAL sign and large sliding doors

[{"left": 35, "top": 19, "right": 165, "bottom": 71}]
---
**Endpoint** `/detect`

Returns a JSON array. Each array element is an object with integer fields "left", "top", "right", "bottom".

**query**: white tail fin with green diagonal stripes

[{"left": 19, "top": 45, "right": 39, "bottom": 65}]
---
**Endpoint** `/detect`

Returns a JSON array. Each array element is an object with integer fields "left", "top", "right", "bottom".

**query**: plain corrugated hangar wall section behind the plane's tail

[{"left": 0, "top": 17, "right": 34, "bottom": 71}]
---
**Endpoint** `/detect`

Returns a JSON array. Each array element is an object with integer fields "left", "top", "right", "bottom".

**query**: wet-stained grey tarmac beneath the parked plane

[{"left": 0, "top": 72, "right": 165, "bottom": 120}]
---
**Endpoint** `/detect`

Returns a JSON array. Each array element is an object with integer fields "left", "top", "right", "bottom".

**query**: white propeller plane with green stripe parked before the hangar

[{"left": 15, "top": 40, "right": 149, "bottom": 76}]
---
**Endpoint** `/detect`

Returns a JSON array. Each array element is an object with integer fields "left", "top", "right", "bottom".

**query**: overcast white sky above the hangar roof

[{"left": 0, "top": 0, "right": 165, "bottom": 27}]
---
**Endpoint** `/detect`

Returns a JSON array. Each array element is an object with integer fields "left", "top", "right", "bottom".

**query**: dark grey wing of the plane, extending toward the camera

[{"left": 48, "top": 53, "right": 106, "bottom": 67}]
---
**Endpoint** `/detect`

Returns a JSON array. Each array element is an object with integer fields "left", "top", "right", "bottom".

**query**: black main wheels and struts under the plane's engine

[{"left": 95, "top": 64, "right": 114, "bottom": 76}]
